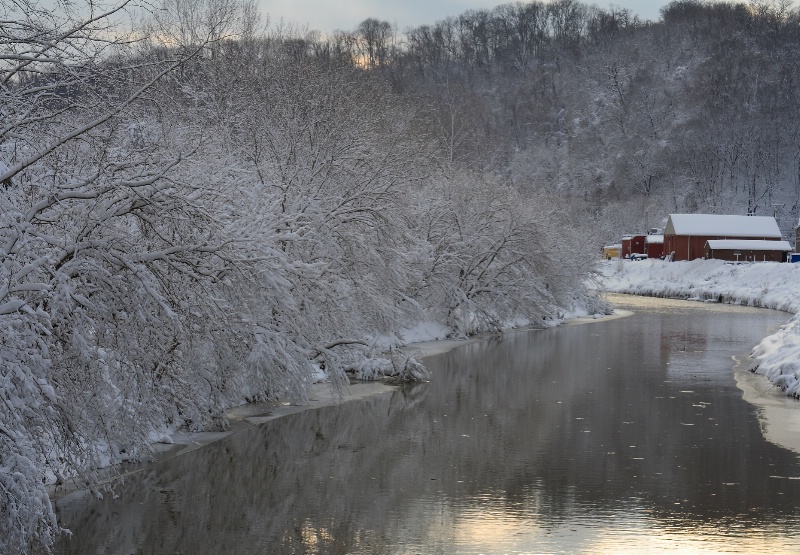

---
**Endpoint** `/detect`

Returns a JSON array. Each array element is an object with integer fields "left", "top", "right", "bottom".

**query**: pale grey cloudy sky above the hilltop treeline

[{"left": 258, "top": 0, "right": 669, "bottom": 33}]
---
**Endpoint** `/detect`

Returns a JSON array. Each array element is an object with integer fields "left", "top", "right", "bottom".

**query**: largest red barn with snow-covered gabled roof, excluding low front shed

[{"left": 664, "top": 214, "right": 782, "bottom": 260}]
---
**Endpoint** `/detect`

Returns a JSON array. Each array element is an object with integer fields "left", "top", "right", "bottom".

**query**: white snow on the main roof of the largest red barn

[{"left": 664, "top": 214, "right": 781, "bottom": 239}]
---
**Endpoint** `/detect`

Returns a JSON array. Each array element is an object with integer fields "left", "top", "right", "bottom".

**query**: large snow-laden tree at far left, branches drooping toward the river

[{"left": 0, "top": 0, "right": 284, "bottom": 552}]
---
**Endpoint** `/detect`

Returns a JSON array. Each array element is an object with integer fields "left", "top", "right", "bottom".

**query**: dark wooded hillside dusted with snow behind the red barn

[{"left": 368, "top": 0, "right": 800, "bottom": 243}]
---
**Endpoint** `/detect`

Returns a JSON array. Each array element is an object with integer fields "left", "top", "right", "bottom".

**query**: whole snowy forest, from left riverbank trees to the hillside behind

[{"left": 0, "top": 0, "right": 800, "bottom": 553}]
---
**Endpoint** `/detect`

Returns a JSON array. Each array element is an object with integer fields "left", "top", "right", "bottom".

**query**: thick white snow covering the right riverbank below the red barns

[{"left": 599, "top": 260, "right": 800, "bottom": 398}]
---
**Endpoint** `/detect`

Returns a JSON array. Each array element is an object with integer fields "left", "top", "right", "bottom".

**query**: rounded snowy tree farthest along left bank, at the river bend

[{"left": 406, "top": 173, "right": 591, "bottom": 335}]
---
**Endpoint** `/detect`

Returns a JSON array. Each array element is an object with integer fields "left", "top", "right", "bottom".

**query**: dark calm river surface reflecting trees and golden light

[{"left": 59, "top": 298, "right": 800, "bottom": 554}]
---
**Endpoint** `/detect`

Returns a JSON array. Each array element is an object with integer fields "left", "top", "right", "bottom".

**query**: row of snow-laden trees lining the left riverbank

[{"left": 0, "top": 0, "right": 600, "bottom": 552}]
